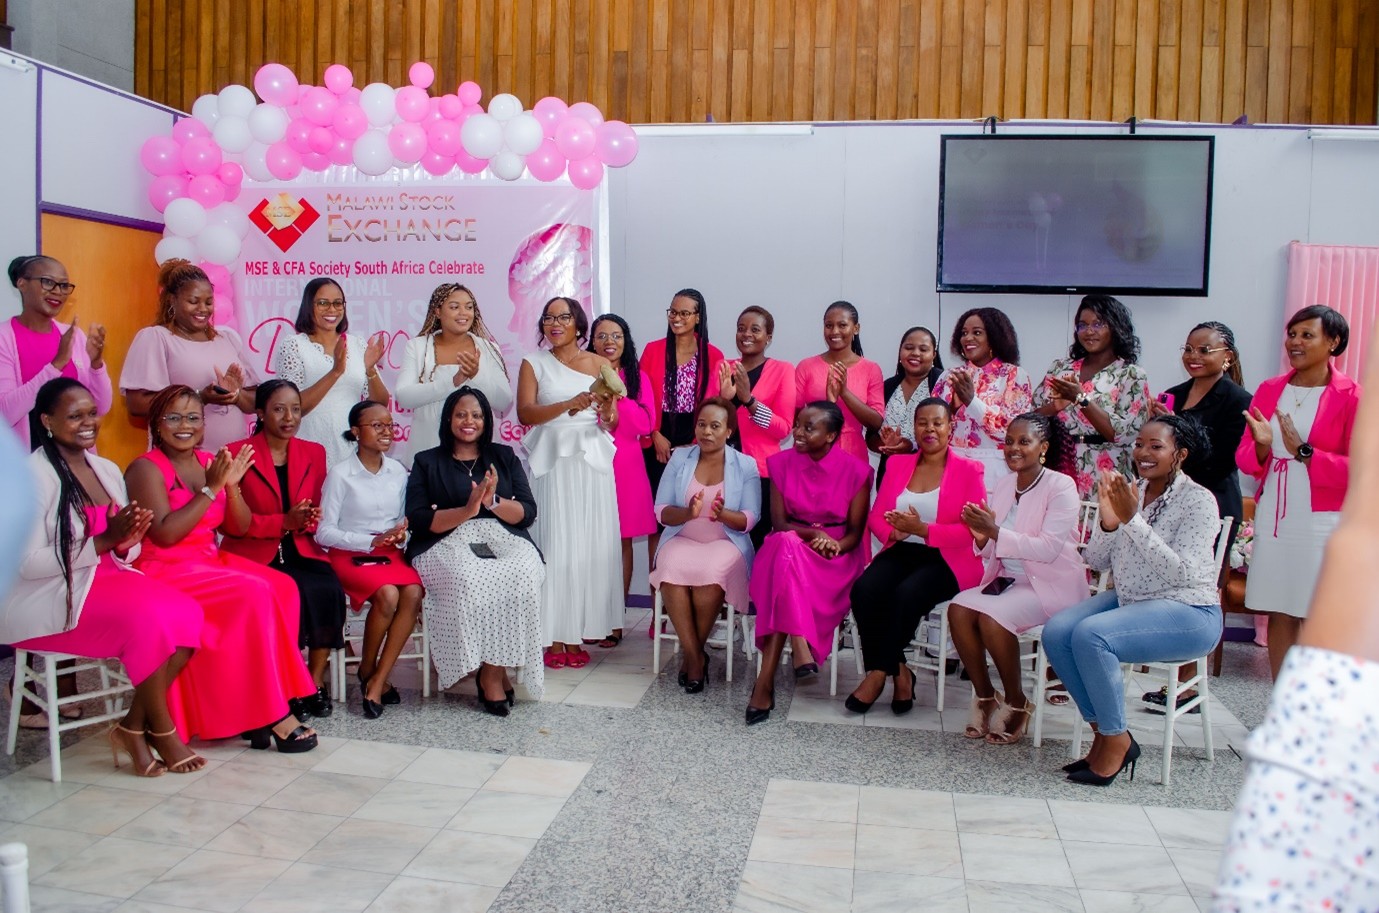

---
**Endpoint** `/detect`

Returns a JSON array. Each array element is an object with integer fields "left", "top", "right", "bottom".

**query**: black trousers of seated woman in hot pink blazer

[{"left": 852, "top": 542, "right": 958, "bottom": 676}]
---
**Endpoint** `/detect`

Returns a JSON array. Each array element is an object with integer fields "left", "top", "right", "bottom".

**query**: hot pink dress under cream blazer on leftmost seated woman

[{"left": 15, "top": 506, "right": 201, "bottom": 684}]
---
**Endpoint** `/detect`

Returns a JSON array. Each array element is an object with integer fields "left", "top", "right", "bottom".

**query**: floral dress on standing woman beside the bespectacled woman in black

[{"left": 1034, "top": 359, "right": 1150, "bottom": 501}]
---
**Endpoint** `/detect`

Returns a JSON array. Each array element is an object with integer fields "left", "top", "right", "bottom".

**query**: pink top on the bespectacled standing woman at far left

[{"left": 0, "top": 317, "right": 110, "bottom": 450}]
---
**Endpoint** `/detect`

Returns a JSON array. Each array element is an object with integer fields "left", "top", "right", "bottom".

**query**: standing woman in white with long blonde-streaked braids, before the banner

[{"left": 397, "top": 283, "right": 513, "bottom": 468}]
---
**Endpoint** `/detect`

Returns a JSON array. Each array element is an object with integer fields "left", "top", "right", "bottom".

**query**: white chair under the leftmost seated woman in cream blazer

[{"left": 6, "top": 650, "right": 134, "bottom": 783}]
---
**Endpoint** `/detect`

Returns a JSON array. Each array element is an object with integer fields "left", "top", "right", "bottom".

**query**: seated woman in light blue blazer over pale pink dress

[{"left": 651, "top": 396, "right": 761, "bottom": 694}]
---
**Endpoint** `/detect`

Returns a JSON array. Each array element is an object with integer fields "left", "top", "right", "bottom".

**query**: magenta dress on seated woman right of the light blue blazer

[{"left": 752, "top": 449, "right": 872, "bottom": 663}]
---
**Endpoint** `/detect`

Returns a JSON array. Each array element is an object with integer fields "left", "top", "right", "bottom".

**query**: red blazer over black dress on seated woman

[{"left": 221, "top": 433, "right": 328, "bottom": 564}]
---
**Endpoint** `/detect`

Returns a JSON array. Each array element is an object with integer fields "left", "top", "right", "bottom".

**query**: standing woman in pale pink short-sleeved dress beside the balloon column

[{"left": 120, "top": 259, "right": 258, "bottom": 452}]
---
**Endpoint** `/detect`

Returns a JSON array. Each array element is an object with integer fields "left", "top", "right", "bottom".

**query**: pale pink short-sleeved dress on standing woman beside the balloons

[{"left": 120, "top": 327, "right": 259, "bottom": 454}]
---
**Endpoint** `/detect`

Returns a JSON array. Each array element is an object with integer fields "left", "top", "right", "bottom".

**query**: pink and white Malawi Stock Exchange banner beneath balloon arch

[{"left": 232, "top": 181, "right": 603, "bottom": 455}]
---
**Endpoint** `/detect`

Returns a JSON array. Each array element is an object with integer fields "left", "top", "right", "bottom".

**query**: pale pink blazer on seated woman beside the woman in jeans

[{"left": 979, "top": 469, "right": 1088, "bottom": 615}]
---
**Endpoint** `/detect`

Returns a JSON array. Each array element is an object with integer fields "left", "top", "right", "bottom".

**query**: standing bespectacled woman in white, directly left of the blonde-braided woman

[{"left": 273, "top": 276, "right": 387, "bottom": 469}]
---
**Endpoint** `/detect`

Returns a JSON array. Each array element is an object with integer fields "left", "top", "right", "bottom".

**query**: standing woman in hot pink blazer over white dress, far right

[{"left": 1236, "top": 305, "right": 1360, "bottom": 679}]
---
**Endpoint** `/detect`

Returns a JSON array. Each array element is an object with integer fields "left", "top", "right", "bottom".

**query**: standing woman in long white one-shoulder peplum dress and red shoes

[{"left": 517, "top": 298, "right": 623, "bottom": 669}]
